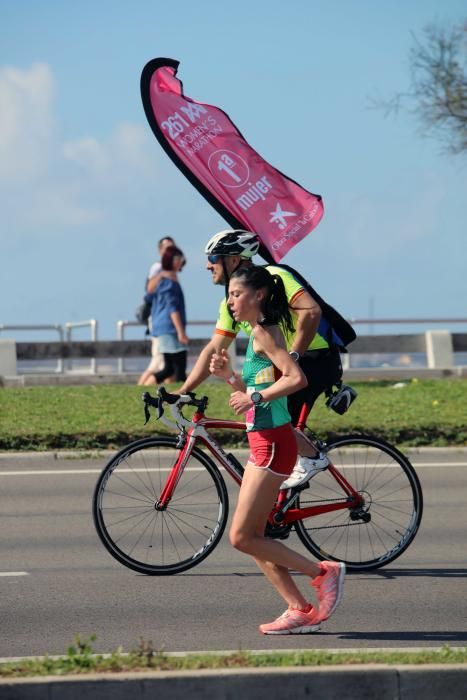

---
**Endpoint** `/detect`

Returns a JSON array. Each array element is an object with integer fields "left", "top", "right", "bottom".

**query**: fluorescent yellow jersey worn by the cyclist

[{"left": 215, "top": 265, "right": 329, "bottom": 350}]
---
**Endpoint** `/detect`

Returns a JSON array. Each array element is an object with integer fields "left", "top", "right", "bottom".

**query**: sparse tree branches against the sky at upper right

[{"left": 377, "top": 20, "right": 467, "bottom": 155}]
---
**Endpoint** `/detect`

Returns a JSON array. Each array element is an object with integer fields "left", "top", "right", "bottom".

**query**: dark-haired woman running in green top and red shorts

[{"left": 210, "top": 267, "right": 345, "bottom": 634}]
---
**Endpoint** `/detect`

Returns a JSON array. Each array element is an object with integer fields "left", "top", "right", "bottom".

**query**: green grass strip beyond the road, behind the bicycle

[{"left": 0, "top": 379, "right": 467, "bottom": 450}]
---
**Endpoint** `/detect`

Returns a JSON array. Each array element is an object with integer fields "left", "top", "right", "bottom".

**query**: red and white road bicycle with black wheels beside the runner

[{"left": 93, "top": 388, "right": 423, "bottom": 576}]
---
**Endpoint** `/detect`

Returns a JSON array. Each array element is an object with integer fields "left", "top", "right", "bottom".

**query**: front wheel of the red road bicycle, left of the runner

[{"left": 93, "top": 436, "right": 229, "bottom": 576}]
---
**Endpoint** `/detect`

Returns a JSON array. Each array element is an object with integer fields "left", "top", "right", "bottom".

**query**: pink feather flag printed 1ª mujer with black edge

[{"left": 141, "top": 58, "right": 323, "bottom": 262}]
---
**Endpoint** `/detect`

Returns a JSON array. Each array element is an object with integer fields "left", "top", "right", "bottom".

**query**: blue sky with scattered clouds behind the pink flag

[{"left": 0, "top": 0, "right": 467, "bottom": 339}]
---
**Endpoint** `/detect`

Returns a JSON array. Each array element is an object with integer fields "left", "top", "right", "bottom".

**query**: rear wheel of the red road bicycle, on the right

[{"left": 295, "top": 435, "right": 423, "bottom": 571}]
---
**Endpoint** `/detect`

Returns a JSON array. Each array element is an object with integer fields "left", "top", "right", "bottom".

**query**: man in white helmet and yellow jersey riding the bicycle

[{"left": 179, "top": 229, "right": 342, "bottom": 488}]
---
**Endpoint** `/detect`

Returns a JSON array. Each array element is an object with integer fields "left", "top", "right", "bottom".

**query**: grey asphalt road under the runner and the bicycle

[{"left": 0, "top": 449, "right": 467, "bottom": 657}]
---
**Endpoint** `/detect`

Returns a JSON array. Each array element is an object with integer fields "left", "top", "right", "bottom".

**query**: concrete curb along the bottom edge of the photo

[{"left": 0, "top": 664, "right": 467, "bottom": 700}]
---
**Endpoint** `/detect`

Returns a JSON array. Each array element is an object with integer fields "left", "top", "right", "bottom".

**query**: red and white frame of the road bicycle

[{"left": 149, "top": 396, "right": 362, "bottom": 526}]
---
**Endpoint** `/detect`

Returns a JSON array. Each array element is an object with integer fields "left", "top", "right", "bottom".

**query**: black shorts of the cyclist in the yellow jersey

[{"left": 287, "top": 348, "right": 342, "bottom": 425}]
